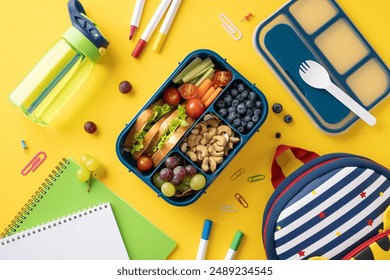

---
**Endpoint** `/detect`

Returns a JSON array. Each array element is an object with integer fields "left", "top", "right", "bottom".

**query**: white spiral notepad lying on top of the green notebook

[{"left": 0, "top": 203, "right": 129, "bottom": 260}]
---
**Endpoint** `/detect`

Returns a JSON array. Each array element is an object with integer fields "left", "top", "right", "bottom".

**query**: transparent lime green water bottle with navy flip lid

[{"left": 9, "top": 0, "right": 109, "bottom": 126}]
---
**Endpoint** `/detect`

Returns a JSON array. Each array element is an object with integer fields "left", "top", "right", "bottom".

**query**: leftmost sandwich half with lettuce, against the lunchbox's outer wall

[{"left": 123, "top": 99, "right": 174, "bottom": 160}]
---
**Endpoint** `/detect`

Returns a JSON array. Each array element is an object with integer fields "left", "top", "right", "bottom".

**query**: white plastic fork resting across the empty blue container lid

[{"left": 299, "top": 60, "right": 376, "bottom": 126}]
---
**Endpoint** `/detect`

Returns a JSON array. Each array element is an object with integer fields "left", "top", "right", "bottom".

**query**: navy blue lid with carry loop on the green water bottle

[{"left": 68, "top": 0, "right": 109, "bottom": 49}]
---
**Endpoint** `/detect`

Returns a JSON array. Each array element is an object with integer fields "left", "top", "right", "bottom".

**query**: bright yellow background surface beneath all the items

[{"left": 0, "top": 0, "right": 390, "bottom": 259}]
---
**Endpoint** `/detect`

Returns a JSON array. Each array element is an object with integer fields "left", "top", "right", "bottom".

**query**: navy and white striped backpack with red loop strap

[{"left": 262, "top": 145, "right": 390, "bottom": 260}]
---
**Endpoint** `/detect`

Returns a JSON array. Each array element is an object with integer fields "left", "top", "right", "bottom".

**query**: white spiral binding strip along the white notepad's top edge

[{"left": 0, "top": 203, "right": 109, "bottom": 246}]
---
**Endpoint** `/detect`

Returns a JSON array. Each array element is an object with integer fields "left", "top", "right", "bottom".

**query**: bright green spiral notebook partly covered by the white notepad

[{"left": 1, "top": 158, "right": 176, "bottom": 260}]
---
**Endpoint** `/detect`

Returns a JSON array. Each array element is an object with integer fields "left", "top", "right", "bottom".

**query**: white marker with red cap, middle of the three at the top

[{"left": 131, "top": 0, "right": 171, "bottom": 58}]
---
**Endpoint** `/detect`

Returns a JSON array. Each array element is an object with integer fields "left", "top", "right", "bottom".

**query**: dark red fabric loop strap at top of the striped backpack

[{"left": 271, "top": 145, "right": 319, "bottom": 189}]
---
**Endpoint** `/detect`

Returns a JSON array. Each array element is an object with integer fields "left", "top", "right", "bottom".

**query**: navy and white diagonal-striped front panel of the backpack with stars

[{"left": 274, "top": 167, "right": 390, "bottom": 259}]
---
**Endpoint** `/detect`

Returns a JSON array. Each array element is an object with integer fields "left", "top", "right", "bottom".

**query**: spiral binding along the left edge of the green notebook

[{"left": 0, "top": 158, "right": 70, "bottom": 238}]
